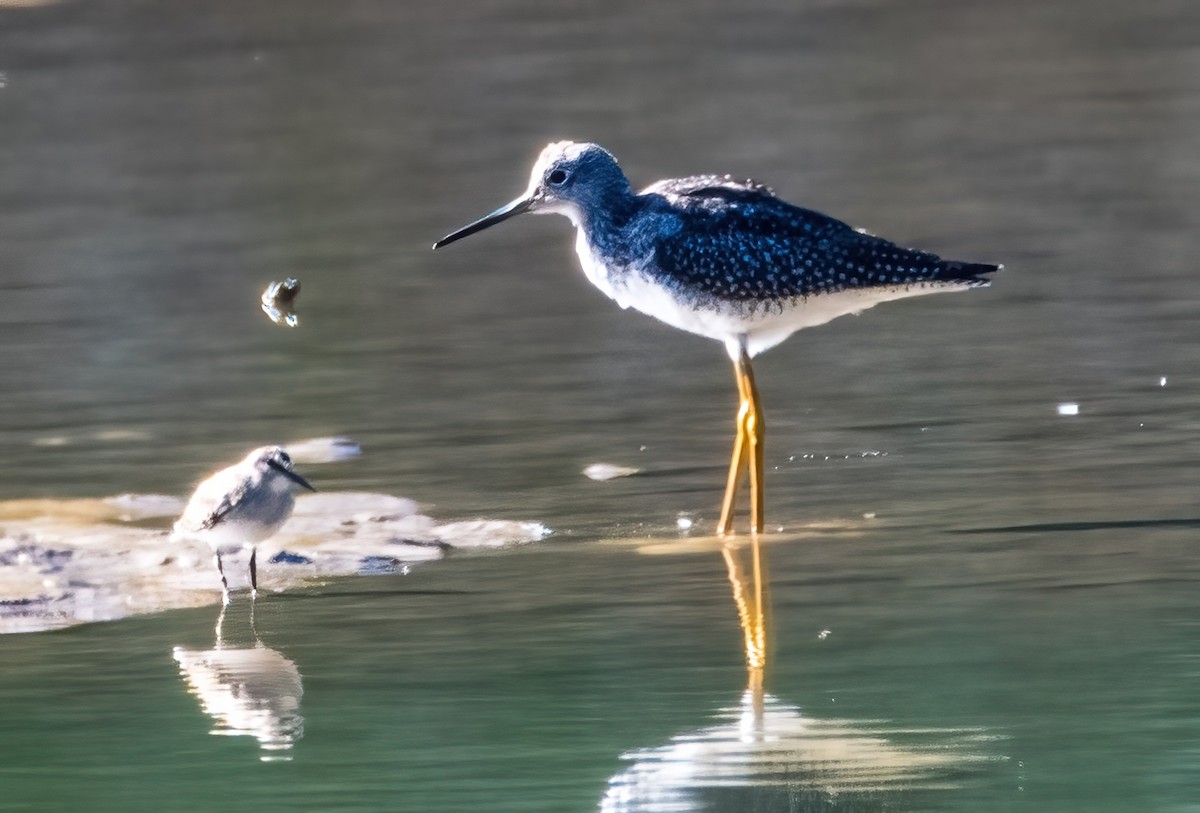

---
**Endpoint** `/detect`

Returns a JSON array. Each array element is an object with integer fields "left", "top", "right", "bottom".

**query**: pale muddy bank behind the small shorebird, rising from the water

[{"left": 0, "top": 492, "right": 550, "bottom": 633}]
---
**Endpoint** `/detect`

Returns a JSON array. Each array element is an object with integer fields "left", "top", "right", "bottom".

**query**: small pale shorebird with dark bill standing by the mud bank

[{"left": 173, "top": 446, "right": 317, "bottom": 604}]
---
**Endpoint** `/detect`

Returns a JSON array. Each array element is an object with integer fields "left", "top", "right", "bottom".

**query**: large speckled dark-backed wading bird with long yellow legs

[{"left": 433, "top": 141, "right": 1001, "bottom": 535}]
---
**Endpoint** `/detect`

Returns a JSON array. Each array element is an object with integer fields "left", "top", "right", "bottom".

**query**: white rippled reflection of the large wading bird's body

[{"left": 600, "top": 685, "right": 991, "bottom": 813}]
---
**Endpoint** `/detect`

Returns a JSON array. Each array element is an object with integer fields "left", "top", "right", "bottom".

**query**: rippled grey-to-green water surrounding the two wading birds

[{"left": 0, "top": 0, "right": 1200, "bottom": 813}]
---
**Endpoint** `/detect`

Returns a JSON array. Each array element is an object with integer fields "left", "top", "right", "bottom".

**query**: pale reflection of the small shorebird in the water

[{"left": 172, "top": 603, "right": 304, "bottom": 761}]
